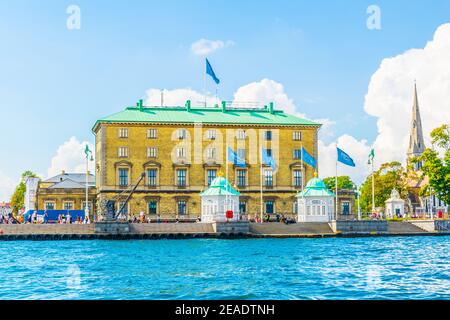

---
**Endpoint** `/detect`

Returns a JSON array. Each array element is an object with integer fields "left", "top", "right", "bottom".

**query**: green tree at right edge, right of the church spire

[{"left": 415, "top": 124, "right": 450, "bottom": 204}]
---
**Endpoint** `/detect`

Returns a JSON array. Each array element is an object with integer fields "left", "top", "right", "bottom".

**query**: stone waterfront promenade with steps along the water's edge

[{"left": 0, "top": 220, "right": 450, "bottom": 240}]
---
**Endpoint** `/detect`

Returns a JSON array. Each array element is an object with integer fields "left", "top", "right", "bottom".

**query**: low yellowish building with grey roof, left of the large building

[{"left": 35, "top": 171, "right": 97, "bottom": 215}]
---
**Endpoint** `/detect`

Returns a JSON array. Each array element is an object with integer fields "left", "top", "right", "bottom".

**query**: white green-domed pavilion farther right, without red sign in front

[{"left": 297, "top": 174, "right": 335, "bottom": 222}]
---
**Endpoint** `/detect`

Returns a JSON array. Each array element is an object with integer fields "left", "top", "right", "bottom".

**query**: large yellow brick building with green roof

[{"left": 93, "top": 101, "right": 321, "bottom": 218}]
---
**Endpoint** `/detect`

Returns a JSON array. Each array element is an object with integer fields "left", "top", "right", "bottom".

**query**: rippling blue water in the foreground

[{"left": 0, "top": 237, "right": 450, "bottom": 299}]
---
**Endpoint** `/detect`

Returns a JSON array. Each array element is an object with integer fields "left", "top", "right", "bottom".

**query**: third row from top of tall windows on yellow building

[{"left": 119, "top": 168, "right": 302, "bottom": 188}]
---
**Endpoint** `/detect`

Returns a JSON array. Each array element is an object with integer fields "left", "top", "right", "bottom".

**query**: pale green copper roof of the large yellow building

[{"left": 94, "top": 107, "right": 320, "bottom": 130}]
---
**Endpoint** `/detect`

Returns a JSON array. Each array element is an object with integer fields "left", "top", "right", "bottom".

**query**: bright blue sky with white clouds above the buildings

[{"left": 0, "top": 0, "right": 450, "bottom": 201}]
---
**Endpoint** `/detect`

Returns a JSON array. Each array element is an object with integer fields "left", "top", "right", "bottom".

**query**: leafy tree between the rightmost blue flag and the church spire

[{"left": 360, "top": 161, "right": 407, "bottom": 212}]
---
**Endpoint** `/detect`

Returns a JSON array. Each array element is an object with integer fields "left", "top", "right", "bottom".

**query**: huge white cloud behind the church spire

[{"left": 364, "top": 24, "right": 450, "bottom": 165}]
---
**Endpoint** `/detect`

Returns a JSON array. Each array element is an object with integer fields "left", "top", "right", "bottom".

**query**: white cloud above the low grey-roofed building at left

[{"left": 47, "top": 137, "right": 94, "bottom": 177}]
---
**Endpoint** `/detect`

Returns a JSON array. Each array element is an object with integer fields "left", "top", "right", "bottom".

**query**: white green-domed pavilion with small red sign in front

[{"left": 200, "top": 176, "right": 240, "bottom": 222}]
